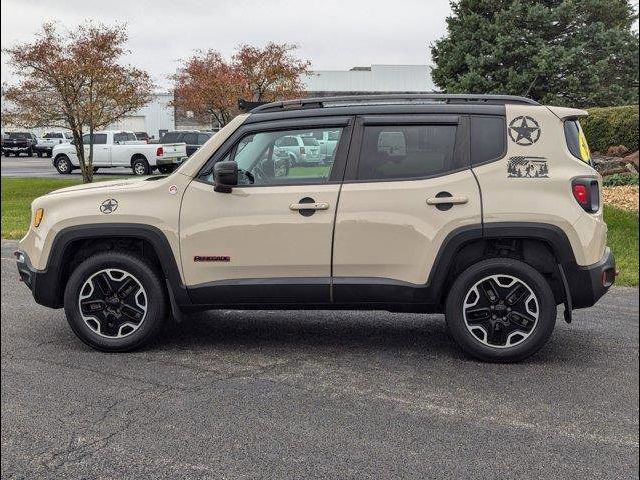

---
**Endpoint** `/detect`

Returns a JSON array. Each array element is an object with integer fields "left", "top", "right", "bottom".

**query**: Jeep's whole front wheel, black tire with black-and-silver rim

[{"left": 64, "top": 251, "right": 167, "bottom": 352}]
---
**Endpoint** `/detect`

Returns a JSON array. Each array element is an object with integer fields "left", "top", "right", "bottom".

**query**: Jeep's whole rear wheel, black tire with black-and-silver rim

[{"left": 445, "top": 258, "right": 557, "bottom": 362}]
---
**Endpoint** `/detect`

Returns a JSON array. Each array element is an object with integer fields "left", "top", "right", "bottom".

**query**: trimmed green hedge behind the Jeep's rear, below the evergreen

[{"left": 580, "top": 105, "right": 638, "bottom": 153}]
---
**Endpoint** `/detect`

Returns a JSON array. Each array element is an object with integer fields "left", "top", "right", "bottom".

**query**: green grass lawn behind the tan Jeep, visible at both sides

[{"left": 2, "top": 177, "right": 638, "bottom": 285}]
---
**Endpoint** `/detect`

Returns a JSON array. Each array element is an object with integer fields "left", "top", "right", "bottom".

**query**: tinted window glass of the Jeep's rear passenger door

[{"left": 357, "top": 125, "right": 457, "bottom": 181}]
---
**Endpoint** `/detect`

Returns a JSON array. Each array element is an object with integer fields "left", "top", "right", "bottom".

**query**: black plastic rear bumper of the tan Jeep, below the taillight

[{"left": 563, "top": 248, "right": 616, "bottom": 309}]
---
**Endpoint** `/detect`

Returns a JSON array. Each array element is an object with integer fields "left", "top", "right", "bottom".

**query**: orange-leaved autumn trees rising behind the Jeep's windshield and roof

[{"left": 171, "top": 43, "right": 310, "bottom": 126}]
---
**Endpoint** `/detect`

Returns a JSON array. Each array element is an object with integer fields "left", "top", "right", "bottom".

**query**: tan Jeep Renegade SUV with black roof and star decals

[{"left": 16, "top": 95, "right": 615, "bottom": 361}]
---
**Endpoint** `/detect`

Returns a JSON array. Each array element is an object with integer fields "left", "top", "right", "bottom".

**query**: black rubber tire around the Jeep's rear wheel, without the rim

[{"left": 446, "top": 258, "right": 557, "bottom": 362}]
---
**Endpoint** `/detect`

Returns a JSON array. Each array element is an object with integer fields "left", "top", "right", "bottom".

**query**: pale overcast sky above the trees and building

[{"left": 0, "top": 0, "right": 450, "bottom": 87}]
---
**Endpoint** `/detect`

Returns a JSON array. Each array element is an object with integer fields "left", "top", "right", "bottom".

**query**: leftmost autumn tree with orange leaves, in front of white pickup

[{"left": 2, "top": 22, "right": 153, "bottom": 182}]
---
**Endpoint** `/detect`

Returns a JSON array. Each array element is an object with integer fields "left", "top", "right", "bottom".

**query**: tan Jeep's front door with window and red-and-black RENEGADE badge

[{"left": 180, "top": 119, "right": 350, "bottom": 305}]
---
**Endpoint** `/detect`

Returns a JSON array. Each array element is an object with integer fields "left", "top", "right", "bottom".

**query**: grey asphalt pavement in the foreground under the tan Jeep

[{"left": 1, "top": 241, "right": 638, "bottom": 479}]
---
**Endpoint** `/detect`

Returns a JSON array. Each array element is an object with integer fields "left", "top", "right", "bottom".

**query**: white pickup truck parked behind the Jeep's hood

[{"left": 52, "top": 130, "right": 187, "bottom": 175}]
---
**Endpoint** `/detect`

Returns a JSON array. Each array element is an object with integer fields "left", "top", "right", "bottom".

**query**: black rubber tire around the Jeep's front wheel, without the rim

[{"left": 64, "top": 252, "right": 166, "bottom": 352}]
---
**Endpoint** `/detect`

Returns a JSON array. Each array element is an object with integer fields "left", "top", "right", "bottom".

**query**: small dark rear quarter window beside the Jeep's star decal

[{"left": 471, "top": 116, "right": 507, "bottom": 165}]
